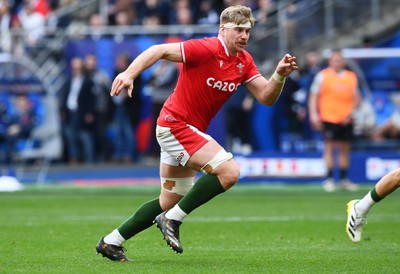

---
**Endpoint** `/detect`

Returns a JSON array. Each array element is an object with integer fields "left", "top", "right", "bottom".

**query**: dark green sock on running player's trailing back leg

[{"left": 118, "top": 198, "right": 163, "bottom": 240}]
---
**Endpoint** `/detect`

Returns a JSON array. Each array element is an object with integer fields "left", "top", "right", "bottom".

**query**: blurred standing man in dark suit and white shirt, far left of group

[{"left": 60, "top": 57, "right": 96, "bottom": 164}]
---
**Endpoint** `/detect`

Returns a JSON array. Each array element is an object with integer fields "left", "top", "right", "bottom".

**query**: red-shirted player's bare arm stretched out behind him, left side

[{"left": 110, "top": 43, "right": 182, "bottom": 97}]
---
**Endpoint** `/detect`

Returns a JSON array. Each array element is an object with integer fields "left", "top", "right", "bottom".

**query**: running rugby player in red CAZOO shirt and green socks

[{"left": 96, "top": 5, "right": 298, "bottom": 261}]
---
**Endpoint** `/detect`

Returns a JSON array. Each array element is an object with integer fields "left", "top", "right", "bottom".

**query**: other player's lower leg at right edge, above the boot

[{"left": 354, "top": 168, "right": 400, "bottom": 216}]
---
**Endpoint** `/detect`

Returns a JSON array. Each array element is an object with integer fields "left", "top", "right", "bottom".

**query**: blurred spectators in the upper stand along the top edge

[{"left": 0, "top": 0, "right": 298, "bottom": 53}]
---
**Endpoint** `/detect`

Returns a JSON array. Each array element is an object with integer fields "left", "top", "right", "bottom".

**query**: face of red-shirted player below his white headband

[{"left": 221, "top": 27, "right": 250, "bottom": 55}]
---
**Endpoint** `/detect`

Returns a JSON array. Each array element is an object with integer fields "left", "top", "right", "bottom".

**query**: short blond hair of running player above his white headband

[{"left": 220, "top": 5, "right": 255, "bottom": 27}]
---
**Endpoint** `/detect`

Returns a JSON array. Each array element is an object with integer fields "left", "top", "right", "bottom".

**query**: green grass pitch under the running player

[{"left": 0, "top": 185, "right": 400, "bottom": 273}]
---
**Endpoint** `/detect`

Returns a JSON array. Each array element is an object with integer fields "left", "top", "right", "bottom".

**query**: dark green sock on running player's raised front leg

[{"left": 178, "top": 174, "right": 225, "bottom": 214}]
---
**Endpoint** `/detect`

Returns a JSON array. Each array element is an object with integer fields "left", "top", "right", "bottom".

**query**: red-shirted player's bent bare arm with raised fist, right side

[{"left": 246, "top": 54, "right": 298, "bottom": 106}]
